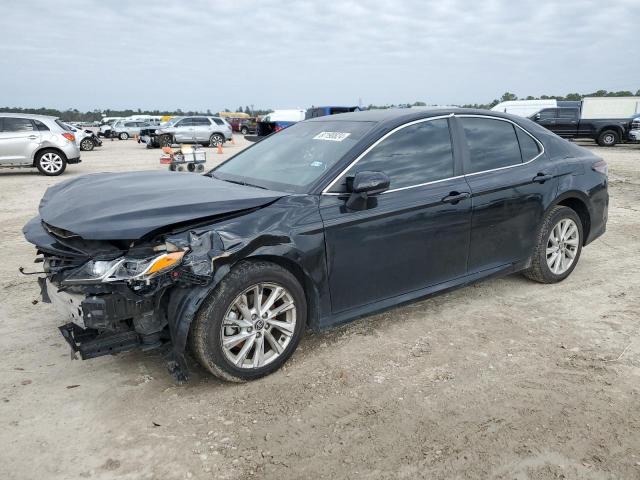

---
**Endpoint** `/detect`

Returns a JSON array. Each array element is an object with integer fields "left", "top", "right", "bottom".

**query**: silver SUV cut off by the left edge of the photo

[{"left": 0, "top": 113, "right": 80, "bottom": 176}]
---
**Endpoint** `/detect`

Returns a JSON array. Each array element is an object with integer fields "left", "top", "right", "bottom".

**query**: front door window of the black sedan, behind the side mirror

[{"left": 347, "top": 119, "right": 453, "bottom": 189}]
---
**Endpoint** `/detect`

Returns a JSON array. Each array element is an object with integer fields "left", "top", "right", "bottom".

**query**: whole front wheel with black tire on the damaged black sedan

[{"left": 189, "top": 261, "right": 307, "bottom": 382}]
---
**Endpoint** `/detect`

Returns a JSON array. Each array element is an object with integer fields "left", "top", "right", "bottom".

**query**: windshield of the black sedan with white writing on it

[{"left": 210, "top": 121, "right": 374, "bottom": 193}]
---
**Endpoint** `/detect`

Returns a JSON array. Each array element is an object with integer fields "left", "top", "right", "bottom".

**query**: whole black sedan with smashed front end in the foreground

[{"left": 24, "top": 109, "right": 608, "bottom": 381}]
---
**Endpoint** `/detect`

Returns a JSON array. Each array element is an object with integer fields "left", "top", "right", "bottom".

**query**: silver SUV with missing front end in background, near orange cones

[{"left": 155, "top": 117, "right": 233, "bottom": 147}]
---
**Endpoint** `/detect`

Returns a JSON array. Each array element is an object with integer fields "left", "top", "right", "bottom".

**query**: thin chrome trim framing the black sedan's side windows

[{"left": 321, "top": 113, "right": 545, "bottom": 196}]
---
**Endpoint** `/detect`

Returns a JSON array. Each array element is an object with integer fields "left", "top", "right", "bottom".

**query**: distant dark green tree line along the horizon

[{"left": 0, "top": 89, "right": 640, "bottom": 122}]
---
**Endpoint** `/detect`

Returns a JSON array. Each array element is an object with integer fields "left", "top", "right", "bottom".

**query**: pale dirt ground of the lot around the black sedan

[{"left": 0, "top": 135, "right": 640, "bottom": 480}]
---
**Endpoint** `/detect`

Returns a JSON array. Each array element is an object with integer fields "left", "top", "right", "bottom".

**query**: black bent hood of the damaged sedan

[{"left": 40, "top": 172, "right": 288, "bottom": 240}]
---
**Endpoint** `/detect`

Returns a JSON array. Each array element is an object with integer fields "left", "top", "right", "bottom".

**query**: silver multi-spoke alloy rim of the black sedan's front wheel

[{"left": 220, "top": 283, "right": 296, "bottom": 369}]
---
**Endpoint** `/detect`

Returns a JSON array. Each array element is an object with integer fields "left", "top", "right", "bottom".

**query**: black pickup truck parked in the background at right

[{"left": 529, "top": 107, "right": 631, "bottom": 147}]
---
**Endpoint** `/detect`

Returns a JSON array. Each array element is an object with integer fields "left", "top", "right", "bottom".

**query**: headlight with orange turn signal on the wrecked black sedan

[{"left": 63, "top": 251, "right": 185, "bottom": 284}]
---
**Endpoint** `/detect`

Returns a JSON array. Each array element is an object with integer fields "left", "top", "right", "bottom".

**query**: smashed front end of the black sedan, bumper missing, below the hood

[{"left": 24, "top": 218, "right": 250, "bottom": 381}]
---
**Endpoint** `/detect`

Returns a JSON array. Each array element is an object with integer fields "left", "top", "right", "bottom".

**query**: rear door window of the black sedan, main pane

[{"left": 460, "top": 117, "right": 522, "bottom": 173}]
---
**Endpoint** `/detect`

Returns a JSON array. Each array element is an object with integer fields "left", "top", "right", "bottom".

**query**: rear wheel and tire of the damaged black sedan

[{"left": 522, "top": 206, "right": 584, "bottom": 283}]
